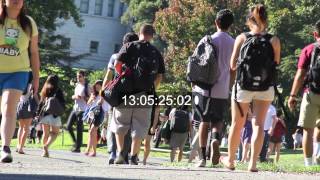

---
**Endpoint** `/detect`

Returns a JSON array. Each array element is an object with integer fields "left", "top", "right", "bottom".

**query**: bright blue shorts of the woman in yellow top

[{"left": 0, "top": 72, "right": 30, "bottom": 96}]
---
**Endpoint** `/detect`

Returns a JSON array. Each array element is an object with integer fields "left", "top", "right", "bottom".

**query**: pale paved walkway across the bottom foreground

[{"left": 0, "top": 149, "right": 320, "bottom": 180}]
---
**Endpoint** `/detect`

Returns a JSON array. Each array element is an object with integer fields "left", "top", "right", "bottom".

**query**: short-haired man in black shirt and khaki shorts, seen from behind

[{"left": 113, "top": 25, "right": 165, "bottom": 165}]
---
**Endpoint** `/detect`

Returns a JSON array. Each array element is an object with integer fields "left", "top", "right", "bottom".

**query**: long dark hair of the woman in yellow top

[{"left": 0, "top": 0, "right": 32, "bottom": 37}]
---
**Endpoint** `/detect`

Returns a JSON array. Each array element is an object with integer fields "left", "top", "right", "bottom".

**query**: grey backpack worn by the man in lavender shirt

[{"left": 187, "top": 35, "right": 219, "bottom": 90}]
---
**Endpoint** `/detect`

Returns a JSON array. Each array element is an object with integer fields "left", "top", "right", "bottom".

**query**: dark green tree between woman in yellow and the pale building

[{"left": 25, "top": 0, "right": 83, "bottom": 122}]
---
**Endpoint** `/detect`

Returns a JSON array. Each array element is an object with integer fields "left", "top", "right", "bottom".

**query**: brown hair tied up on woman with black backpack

[{"left": 247, "top": 4, "right": 268, "bottom": 28}]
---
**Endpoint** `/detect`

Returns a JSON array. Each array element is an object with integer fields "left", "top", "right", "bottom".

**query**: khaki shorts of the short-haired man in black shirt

[{"left": 113, "top": 107, "right": 152, "bottom": 139}]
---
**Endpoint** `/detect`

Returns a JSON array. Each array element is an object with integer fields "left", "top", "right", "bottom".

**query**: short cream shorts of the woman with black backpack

[{"left": 231, "top": 84, "right": 274, "bottom": 103}]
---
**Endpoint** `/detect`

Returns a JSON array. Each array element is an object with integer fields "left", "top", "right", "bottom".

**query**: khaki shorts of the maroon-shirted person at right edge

[{"left": 298, "top": 92, "right": 320, "bottom": 128}]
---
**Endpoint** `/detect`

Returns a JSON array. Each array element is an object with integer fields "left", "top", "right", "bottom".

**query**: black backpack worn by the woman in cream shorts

[{"left": 236, "top": 33, "right": 276, "bottom": 91}]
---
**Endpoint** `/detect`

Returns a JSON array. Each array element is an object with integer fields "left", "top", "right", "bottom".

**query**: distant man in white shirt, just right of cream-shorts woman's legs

[{"left": 260, "top": 104, "right": 277, "bottom": 162}]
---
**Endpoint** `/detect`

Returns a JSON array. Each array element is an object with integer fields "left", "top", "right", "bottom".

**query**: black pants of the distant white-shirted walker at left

[{"left": 67, "top": 111, "right": 83, "bottom": 149}]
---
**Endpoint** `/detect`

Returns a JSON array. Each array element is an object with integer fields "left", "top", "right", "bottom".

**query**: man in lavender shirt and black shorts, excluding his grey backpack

[{"left": 190, "top": 9, "right": 234, "bottom": 167}]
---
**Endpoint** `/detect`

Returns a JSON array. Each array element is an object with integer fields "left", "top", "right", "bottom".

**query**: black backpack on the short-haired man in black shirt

[{"left": 127, "top": 41, "right": 159, "bottom": 93}]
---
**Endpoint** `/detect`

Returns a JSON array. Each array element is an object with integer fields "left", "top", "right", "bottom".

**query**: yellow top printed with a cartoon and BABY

[{"left": 0, "top": 16, "right": 38, "bottom": 73}]
